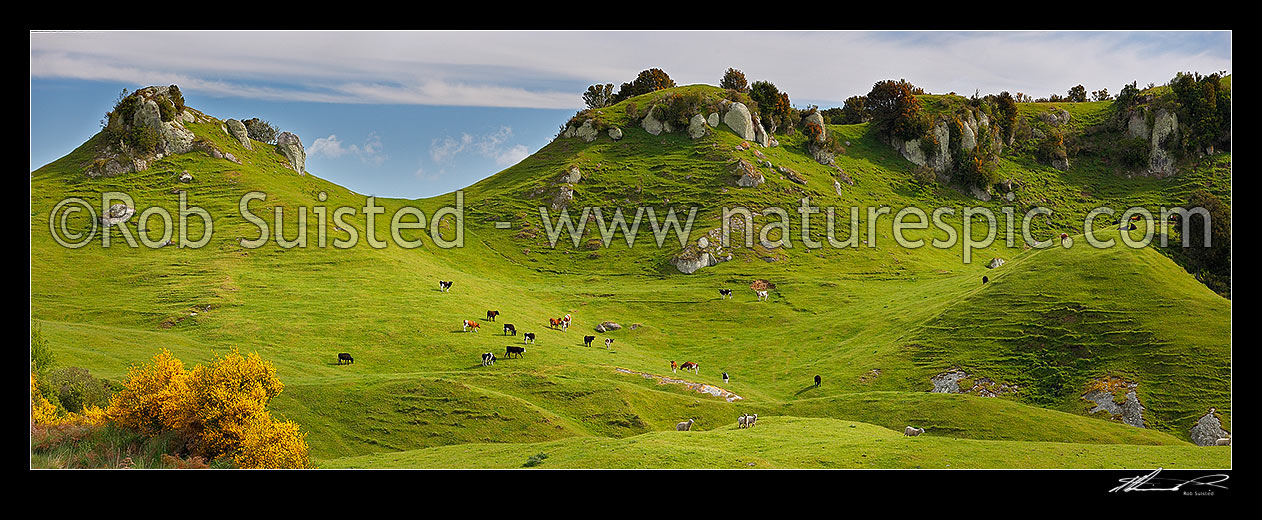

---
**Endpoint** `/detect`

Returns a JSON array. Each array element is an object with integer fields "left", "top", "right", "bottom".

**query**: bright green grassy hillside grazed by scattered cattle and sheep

[{"left": 30, "top": 86, "right": 1230, "bottom": 467}]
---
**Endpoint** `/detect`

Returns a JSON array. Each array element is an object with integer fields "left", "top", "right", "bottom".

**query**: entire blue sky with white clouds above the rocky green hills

[{"left": 30, "top": 32, "right": 1232, "bottom": 197}]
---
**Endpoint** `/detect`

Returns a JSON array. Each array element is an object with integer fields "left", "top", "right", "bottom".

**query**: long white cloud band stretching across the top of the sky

[{"left": 30, "top": 30, "right": 1232, "bottom": 109}]
